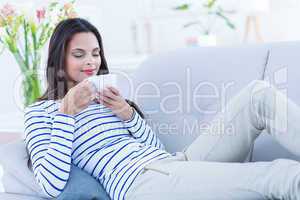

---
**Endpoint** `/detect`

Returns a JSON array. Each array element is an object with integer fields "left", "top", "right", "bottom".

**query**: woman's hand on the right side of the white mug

[{"left": 97, "top": 87, "right": 133, "bottom": 121}]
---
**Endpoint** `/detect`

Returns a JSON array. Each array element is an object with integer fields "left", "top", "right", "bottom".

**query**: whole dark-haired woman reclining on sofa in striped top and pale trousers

[{"left": 25, "top": 18, "right": 300, "bottom": 200}]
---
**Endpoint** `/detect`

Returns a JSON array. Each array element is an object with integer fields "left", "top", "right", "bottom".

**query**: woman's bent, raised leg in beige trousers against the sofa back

[{"left": 184, "top": 81, "right": 300, "bottom": 162}]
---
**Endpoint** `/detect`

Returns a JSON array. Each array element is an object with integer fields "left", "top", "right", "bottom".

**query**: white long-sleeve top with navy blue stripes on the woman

[{"left": 25, "top": 100, "right": 171, "bottom": 200}]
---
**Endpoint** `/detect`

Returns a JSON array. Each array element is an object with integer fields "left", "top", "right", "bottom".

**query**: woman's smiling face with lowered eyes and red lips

[{"left": 65, "top": 32, "right": 101, "bottom": 86}]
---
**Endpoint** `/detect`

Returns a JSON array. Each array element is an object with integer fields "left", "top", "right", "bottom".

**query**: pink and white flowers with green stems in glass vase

[{"left": 0, "top": 1, "right": 76, "bottom": 106}]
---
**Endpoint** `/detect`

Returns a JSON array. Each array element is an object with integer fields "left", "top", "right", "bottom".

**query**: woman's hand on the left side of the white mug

[{"left": 59, "top": 80, "right": 96, "bottom": 115}]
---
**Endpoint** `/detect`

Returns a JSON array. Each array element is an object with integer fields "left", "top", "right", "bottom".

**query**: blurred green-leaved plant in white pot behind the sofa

[{"left": 173, "top": 0, "right": 235, "bottom": 43}]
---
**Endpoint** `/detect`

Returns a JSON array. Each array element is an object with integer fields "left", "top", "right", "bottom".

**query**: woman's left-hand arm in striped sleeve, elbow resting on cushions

[{"left": 25, "top": 102, "right": 75, "bottom": 198}]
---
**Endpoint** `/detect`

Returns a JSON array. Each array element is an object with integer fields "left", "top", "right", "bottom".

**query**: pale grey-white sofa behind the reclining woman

[{"left": 0, "top": 42, "right": 300, "bottom": 200}]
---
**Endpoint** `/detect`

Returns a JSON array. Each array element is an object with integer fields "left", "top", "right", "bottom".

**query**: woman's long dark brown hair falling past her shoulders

[{"left": 28, "top": 18, "right": 144, "bottom": 168}]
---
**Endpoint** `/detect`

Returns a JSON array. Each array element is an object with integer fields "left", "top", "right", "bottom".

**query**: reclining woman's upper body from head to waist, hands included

[{"left": 25, "top": 19, "right": 170, "bottom": 199}]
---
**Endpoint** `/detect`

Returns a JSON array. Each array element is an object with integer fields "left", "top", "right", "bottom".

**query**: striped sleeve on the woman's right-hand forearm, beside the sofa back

[{"left": 123, "top": 109, "right": 165, "bottom": 150}]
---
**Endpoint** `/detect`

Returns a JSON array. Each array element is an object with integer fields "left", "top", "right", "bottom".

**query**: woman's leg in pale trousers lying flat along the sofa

[{"left": 125, "top": 159, "right": 300, "bottom": 200}]
